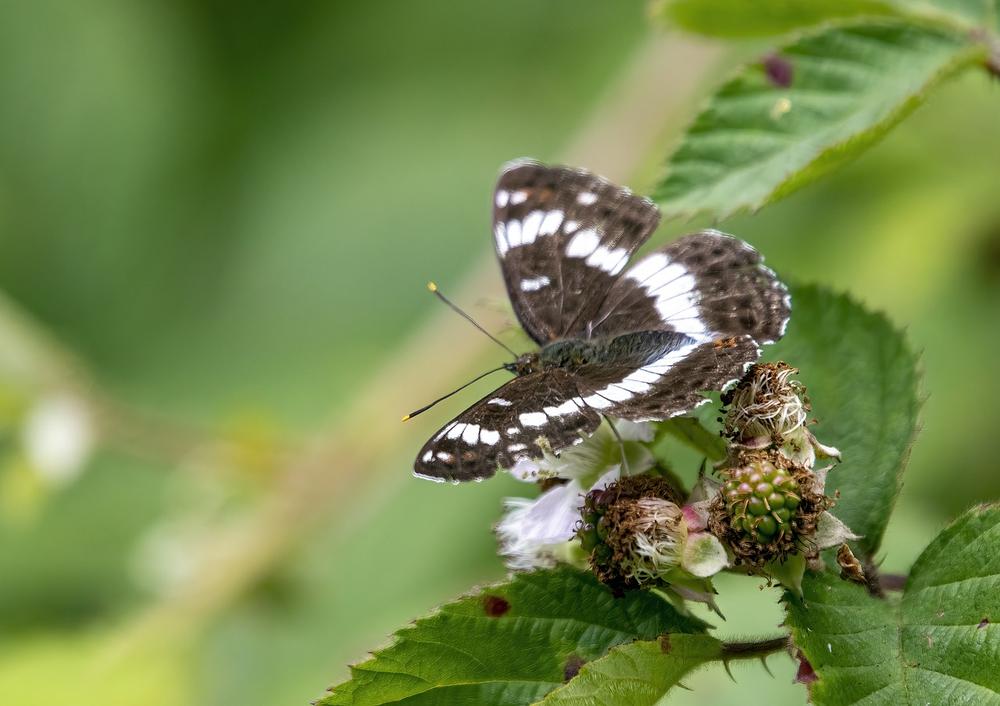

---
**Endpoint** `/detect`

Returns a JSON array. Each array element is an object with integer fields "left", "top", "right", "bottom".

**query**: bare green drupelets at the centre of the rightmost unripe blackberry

[{"left": 723, "top": 460, "right": 801, "bottom": 544}]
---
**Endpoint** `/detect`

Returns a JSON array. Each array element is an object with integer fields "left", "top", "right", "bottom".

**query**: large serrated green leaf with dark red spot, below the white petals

[{"left": 319, "top": 568, "right": 705, "bottom": 706}]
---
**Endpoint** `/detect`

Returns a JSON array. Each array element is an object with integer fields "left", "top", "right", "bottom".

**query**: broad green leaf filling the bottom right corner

[{"left": 787, "top": 505, "right": 1000, "bottom": 706}]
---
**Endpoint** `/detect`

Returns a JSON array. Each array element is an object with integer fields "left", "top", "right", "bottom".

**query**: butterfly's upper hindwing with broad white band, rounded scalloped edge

[{"left": 593, "top": 231, "right": 790, "bottom": 343}]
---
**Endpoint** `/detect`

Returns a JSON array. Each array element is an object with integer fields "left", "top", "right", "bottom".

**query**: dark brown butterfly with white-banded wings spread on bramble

[{"left": 414, "top": 160, "right": 791, "bottom": 481}]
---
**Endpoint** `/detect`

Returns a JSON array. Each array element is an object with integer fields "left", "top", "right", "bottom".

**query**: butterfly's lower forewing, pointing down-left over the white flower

[{"left": 414, "top": 369, "right": 601, "bottom": 481}]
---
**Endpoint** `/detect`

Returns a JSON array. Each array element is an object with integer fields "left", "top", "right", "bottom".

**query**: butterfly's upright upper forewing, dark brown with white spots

[{"left": 493, "top": 161, "right": 660, "bottom": 345}]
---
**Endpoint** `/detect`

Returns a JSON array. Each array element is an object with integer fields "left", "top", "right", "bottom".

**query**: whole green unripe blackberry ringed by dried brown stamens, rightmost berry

[{"left": 709, "top": 450, "right": 830, "bottom": 568}]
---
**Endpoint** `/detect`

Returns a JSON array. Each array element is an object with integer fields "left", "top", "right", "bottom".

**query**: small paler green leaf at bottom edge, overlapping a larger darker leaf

[{"left": 542, "top": 635, "right": 722, "bottom": 706}]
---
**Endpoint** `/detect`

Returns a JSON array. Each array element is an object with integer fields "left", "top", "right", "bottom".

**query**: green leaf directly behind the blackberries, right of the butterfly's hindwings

[{"left": 765, "top": 286, "right": 920, "bottom": 555}]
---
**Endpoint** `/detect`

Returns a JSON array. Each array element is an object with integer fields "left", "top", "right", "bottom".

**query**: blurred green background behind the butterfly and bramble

[{"left": 0, "top": 0, "right": 1000, "bottom": 706}]
